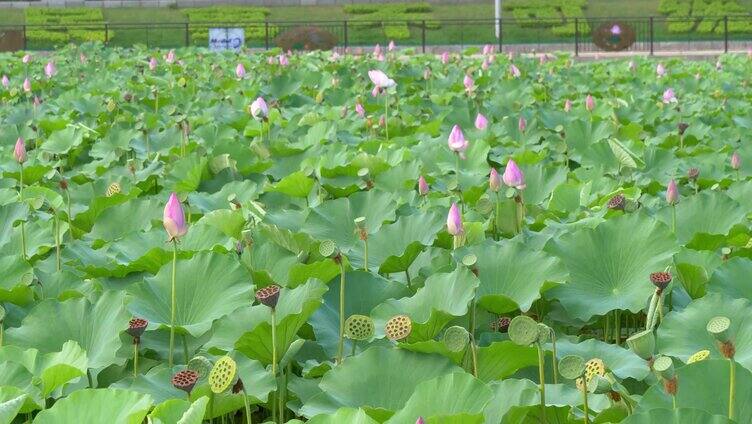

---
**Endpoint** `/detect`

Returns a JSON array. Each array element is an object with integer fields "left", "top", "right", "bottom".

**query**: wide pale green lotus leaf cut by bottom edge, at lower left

[{"left": 34, "top": 389, "right": 152, "bottom": 424}]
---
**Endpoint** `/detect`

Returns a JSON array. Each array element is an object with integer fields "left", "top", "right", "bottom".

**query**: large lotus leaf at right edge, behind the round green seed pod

[{"left": 658, "top": 294, "right": 752, "bottom": 370}]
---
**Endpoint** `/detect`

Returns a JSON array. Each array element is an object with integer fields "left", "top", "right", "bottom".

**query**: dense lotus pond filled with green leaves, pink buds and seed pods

[{"left": 0, "top": 46, "right": 752, "bottom": 424}]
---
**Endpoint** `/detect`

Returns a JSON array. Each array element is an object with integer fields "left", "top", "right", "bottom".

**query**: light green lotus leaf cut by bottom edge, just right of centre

[{"left": 387, "top": 373, "right": 493, "bottom": 423}]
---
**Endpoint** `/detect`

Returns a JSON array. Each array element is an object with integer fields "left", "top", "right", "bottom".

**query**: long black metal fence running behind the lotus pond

[{"left": 0, "top": 15, "right": 752, "bottom": 55}]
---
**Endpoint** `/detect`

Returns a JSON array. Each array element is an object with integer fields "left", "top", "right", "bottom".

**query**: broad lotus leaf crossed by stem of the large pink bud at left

[{"left": 128, "top": 252, "right": 253, "bottom": 337}]
